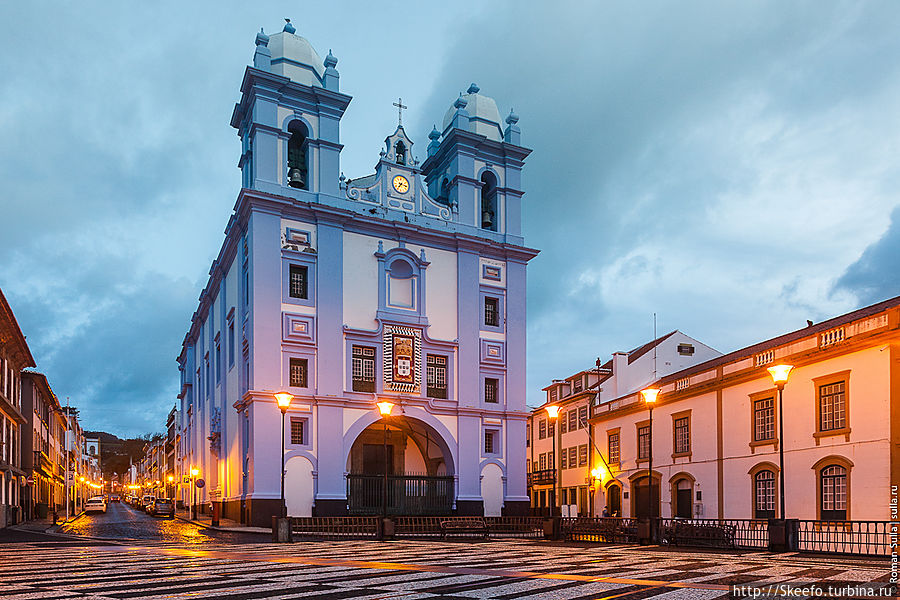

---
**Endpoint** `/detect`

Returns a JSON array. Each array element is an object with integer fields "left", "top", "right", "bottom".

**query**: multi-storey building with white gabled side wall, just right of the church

[{"left": 526, "top": 330, "right": 721, "bottom": 516}]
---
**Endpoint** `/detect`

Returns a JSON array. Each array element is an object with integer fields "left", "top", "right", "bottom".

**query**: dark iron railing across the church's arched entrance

[{"left": 347, "top": 474, "right": 454, "bottom": 515}]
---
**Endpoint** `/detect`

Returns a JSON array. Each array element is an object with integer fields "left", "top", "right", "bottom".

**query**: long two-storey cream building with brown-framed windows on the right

[{"left": 590, "top": 298, "right": 900, "bottom": 521}]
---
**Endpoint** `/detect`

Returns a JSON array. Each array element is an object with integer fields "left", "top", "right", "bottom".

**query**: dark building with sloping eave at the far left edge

[{"left": 0, "top": 291, "right": 35, "bottom": 527}]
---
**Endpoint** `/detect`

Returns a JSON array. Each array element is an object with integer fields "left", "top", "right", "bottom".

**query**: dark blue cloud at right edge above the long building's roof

[{"left": 835, "top": 207, "right": 900, "bottom": 304}]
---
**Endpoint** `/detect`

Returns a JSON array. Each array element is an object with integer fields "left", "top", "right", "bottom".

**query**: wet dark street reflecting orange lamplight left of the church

[{"left": 59, "top": 502, "right": 270, "bottom": 546}]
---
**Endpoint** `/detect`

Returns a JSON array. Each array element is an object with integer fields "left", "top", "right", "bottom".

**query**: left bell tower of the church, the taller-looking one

[{"left": 231, "top": 19, "right": 351, "bottom": 201}]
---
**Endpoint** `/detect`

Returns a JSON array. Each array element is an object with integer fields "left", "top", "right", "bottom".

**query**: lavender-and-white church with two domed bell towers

[{"left": 177, "top": 23, "right": 537, "bottom": 524}]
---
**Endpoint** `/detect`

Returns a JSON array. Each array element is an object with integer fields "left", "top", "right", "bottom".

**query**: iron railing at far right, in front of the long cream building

[{"left": 799, "top": 520, "right": 896, "bottom": 556}]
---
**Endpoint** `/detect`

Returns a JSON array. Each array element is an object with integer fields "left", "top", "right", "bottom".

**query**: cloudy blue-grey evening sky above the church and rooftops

[{"left": 0, "top": 0, "right": 900, "bottom": 435}]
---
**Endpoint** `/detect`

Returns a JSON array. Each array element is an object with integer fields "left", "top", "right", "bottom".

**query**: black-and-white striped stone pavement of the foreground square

[{"left": 0, "top": 538, "right": 890, "bottom": 600}]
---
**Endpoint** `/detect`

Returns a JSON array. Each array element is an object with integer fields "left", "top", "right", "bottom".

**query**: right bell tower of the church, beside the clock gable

[{"left": 422, "top": 83, "right": 531, "bottom": 244}]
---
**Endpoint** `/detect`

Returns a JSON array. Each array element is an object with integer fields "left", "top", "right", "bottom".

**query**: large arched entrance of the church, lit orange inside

[{"left": 347, "top": 415, "right": 456, "bottom": 515}]
